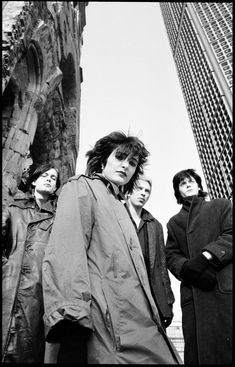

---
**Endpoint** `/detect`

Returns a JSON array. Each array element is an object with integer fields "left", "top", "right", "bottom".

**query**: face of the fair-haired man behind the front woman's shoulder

[{"left": 129, "top": 179, "right": 151, "bottom": 208}]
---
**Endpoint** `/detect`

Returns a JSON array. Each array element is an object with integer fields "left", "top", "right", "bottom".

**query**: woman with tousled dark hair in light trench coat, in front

[{"left": 43, "top": 132, "right": 182, "bottom": 364}]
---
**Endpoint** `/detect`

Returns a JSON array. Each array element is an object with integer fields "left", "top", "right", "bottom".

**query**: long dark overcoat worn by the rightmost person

[{"left": 166, "top": 196, "right": 232, "bottom": 364}]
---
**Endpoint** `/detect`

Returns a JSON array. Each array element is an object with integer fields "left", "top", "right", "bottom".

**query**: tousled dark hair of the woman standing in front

[{"left": 86, "top": 131, "right": 149, "bottom": 193}]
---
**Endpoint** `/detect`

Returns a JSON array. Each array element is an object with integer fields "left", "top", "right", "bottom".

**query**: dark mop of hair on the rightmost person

[{"left": 173, "top": 168, "right": 207, "bottom": 204}]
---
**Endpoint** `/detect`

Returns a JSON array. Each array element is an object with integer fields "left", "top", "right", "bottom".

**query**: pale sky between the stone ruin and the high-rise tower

[{"left": 76, "top": 1, "right": 207, "bottom": 320}]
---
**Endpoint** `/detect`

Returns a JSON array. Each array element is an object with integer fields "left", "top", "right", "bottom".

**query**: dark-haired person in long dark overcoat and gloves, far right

[{"left": 166, "top": 169, "right": 232, "bottom": 364}]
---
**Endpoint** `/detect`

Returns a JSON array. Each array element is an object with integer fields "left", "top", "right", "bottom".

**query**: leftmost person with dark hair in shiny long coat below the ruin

[{"left": 2, "top": 164, "right": 60, "bottom": 363}]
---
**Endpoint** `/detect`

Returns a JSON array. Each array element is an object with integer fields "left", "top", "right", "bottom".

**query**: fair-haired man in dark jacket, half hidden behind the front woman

[{"left": 128, "top": 176, "right": 175, "bottom": 328}]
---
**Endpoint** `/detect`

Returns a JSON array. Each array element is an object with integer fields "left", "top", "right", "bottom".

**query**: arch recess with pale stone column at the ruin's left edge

[{"left": 2, "top": 40, "right": 42, "bottom": 207}]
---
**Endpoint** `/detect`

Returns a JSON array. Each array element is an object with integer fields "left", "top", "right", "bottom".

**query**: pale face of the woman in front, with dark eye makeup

[{"left": 102, "top": 149, "right": 139, "bottom": 186}]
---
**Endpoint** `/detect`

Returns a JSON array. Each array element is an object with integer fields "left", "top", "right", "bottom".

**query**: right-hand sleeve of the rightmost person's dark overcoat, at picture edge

[{"left": 202, "top": 199, "right": 233, "bottom": 267}]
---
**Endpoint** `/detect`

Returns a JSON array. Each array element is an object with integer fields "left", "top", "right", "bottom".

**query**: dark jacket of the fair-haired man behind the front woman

[{"left": 137, "top": 208, "right": 175, "bottom": 322}]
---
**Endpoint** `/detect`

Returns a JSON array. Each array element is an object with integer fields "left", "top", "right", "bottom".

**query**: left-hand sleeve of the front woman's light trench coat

[{"left": 43, "top": 178, "right": 94, "bottom": 342}]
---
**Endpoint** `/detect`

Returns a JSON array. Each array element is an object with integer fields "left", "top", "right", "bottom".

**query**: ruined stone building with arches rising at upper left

[{"left": 2, "top": 1, "right": 88, "bottom": 205}]
